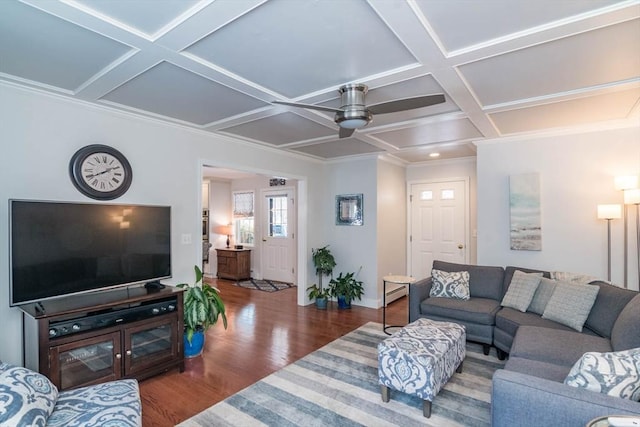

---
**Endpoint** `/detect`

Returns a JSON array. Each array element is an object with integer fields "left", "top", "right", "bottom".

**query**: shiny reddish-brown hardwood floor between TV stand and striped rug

[{"left": 140, "top": 279, "right": 407, "bottom": 427}]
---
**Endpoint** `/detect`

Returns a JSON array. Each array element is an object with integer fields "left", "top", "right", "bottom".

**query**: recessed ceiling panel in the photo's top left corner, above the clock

[{"left": 0, "top": 1, "right": 131, "bottom": 91}]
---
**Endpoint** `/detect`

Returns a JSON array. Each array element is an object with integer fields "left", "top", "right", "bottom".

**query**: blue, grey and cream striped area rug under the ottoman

[{"left": 179, "top": 322, "right": 504, "bottom": 427}]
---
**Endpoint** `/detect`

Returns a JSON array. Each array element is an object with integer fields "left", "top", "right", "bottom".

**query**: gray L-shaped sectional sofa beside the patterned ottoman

[{"left": 409, "top": 261, "right": 640, "bottom": 427}]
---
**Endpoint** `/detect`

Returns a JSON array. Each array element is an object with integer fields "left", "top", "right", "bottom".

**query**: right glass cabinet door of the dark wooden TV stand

[{"left": 123, "top": 315, "right": 179, "bottom": 376}]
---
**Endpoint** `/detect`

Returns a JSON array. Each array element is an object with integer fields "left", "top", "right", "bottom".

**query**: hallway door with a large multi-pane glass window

[{"left": 262, "top": 188, "right": 296, "bottom": 283}]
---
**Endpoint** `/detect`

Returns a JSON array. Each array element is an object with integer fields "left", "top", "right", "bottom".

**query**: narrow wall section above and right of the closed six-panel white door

[{"left": 407, "top": 157, "right": 478, "bottom": 264}]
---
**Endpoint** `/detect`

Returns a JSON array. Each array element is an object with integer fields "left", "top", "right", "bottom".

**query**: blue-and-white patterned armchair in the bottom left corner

[{"left": 0, "top": 363, "right": 142, "bottom": 427}]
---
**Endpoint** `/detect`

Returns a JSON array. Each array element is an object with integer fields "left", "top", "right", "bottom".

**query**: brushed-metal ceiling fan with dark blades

[{"left": 272, "top": 83, "right": 444, "bottom": 138}]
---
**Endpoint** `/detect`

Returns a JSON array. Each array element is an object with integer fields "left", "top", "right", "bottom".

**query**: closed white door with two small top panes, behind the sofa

[{"left": 409, "top": 180, "right": 468, "bottom": 278}]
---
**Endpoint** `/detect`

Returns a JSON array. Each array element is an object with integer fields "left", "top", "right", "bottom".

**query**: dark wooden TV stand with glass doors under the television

[{"left": 20, "top": 286, "right": 184, "bottom": 390}]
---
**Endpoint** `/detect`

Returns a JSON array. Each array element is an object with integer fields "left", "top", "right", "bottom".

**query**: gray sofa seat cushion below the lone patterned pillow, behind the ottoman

[{"left": 420, "top": 298, "right": 500, "bottom": 325}]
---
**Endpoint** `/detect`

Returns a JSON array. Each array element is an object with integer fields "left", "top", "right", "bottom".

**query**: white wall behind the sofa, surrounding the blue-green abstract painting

[{"left": 477, "top": 127, "right": 640, "bottom": 289}]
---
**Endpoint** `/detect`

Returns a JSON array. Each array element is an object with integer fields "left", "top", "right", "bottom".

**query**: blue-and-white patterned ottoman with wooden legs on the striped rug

[{"left": 378, "top": 319, "right": 466, "bottom": 418}]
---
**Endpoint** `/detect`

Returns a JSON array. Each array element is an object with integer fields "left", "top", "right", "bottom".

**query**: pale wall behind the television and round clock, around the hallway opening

[{"left": 0, "top": 84, "right": 326, "bottom": 363}]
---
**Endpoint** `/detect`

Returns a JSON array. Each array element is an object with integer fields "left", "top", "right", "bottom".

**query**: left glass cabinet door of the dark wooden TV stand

[{"left": 49, "top": 332, "right": 122, "bottom": 390}]
